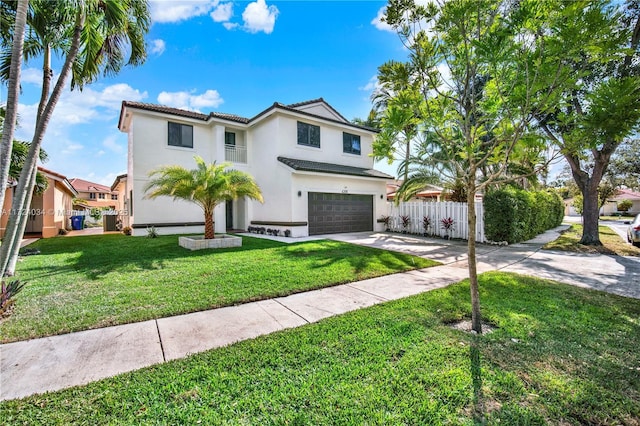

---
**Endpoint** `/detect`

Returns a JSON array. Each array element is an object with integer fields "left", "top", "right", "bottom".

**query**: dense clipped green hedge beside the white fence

[{"left": 483, "top": 189, "right": 564, "bottom": 244}]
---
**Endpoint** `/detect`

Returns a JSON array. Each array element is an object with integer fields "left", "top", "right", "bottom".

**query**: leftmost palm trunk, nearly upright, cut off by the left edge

[{"left": 0, "top": 0, "right": 29, "bottom": 213}]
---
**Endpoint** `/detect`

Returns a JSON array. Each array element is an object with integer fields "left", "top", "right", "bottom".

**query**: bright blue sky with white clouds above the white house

[{"left": 5, "top": 0, "right": 407, "bottom": 185}]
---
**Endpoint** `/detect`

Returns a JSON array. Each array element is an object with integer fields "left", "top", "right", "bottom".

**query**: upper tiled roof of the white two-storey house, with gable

[{"left": 118, "top": 98, "right": 379, "bottom": 133}]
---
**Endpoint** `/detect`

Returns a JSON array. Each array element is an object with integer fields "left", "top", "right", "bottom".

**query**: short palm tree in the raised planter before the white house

[{"left": 145, "top": 156, "right": 263, "bottom": 239}]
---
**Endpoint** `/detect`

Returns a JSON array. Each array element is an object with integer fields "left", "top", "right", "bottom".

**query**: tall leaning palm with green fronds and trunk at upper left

[{"left": 0, "top": 0, "right": 150, "bottom": 276}]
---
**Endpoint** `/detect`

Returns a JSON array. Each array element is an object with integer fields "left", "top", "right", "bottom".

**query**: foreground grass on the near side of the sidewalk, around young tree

[{"left": 0, "top": 273, "right": 640, "bottom": 425}]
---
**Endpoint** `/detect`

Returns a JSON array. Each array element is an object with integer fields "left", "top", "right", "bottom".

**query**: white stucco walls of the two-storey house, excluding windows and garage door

[{"left": 125, "top": 105, "right": 386, "bottom": 236}]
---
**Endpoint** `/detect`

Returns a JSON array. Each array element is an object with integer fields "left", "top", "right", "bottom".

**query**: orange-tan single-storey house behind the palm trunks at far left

[{"left": 0, "top": 167, "right": 78, "bottom": 238}]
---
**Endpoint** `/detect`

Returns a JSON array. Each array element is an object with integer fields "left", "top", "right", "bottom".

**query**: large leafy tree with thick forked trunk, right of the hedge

[{"left": 537, "top": 0, "right": 640, "bottom": 245}]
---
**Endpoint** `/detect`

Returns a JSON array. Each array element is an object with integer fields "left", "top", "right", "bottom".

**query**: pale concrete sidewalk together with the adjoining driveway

[{"left": 0, "top": 225, "right": 640, "bottom": 400}]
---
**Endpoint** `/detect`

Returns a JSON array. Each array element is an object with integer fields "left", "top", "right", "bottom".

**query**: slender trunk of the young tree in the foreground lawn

[{"left": 467, "top": 176, "right": 482, "bottom": 334}]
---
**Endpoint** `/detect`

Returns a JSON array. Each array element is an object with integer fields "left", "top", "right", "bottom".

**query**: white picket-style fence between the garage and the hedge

[{"left": 388, "top": 201, "right": 485, "bottom": 242}]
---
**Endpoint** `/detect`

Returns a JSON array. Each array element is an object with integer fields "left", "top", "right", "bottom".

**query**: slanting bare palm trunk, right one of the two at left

[{"left": 0, "top": 5, "right": 85, "bottom": 277}]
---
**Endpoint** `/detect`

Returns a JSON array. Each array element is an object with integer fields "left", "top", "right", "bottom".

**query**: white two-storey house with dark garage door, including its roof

[{"left": 118, "top": 99, "right": 393, "bottom": 237}]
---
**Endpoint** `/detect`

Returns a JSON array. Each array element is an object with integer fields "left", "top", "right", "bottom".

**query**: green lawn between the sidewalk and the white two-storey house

[{"left": 0, "top": 235, "right": 438, "bottom": 342}]
